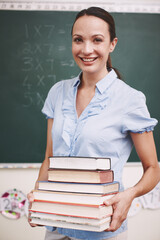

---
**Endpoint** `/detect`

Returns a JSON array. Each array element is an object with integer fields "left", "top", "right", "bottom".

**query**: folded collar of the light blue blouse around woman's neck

[{"left": 73, "top": 69, "right": 117, "bottom": 94}]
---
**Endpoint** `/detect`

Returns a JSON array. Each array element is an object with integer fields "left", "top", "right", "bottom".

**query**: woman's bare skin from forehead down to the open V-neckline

[{"left": 72, "top": 15, "right": 117, "bottom": 117}]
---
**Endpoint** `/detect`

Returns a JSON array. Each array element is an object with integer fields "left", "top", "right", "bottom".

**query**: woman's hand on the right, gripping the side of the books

[{"left": 104, "top": 188, "right": 134, "bottom": 232}]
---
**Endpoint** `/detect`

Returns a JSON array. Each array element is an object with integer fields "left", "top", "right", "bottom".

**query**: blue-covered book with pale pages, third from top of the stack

[{"left": 38, "top": 181, "right": 119, "bottom": 194}]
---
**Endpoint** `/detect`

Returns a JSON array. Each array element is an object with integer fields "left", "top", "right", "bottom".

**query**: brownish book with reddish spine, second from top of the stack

[{"left": 48, "top": 168, "right": 114, "bottom": 183}]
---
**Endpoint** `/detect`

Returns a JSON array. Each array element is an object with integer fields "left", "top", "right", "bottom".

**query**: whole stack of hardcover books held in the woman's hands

[{"left": 30, "top": 157, "right": 119, "bottom": 232}]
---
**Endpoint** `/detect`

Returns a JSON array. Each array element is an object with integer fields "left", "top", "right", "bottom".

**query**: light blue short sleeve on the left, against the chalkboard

[{"left": 42, "top": 82, "right": 62, "bottom": 119}]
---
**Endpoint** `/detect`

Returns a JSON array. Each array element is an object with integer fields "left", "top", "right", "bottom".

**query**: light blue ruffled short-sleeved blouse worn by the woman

[{"left": 42, "top": 69, "right": 157, "bottom": 240}]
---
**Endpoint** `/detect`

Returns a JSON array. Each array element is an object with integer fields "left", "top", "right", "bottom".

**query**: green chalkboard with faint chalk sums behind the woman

[{"left": 0, "top": 11, "right": 160, "bottom": 163}]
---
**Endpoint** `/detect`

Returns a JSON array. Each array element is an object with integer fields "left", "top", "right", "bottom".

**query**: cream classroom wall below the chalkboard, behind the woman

[{"left": 0, "top": 163, "right": 160, "bottom": 240}]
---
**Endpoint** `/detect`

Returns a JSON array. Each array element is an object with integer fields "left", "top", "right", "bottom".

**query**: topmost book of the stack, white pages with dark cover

[{"left": 49, "top": 156, "right": 111, "bottom": 170}]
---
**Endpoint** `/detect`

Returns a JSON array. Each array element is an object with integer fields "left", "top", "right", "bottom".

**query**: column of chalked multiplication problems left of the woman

[{"left": 21, "top": 24, "right": 56, "bottom": 108}]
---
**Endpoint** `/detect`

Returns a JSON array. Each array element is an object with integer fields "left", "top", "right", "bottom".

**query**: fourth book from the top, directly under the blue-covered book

[{"left": 33, "top": 190, "right": 113, "bottom": 206}]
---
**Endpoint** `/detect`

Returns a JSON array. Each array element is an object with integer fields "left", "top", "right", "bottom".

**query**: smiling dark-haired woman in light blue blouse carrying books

[{"left": 29, "top": 7, "right": 160, "bottom": 240}]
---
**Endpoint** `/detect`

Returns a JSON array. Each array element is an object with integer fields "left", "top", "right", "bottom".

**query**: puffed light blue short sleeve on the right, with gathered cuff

[{"left": 122, "top": 91, "right": 158, "bottom": 133}]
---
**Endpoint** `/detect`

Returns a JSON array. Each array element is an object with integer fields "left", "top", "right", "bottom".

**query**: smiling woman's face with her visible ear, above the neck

[{"left": 72, "top": 15, "right": 117, "bottom": 76}]
